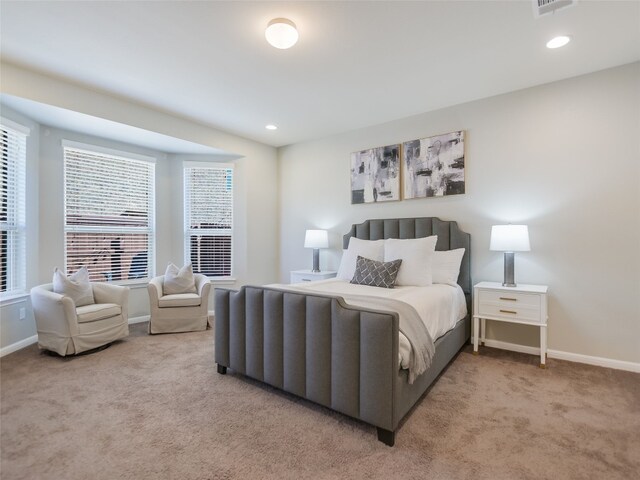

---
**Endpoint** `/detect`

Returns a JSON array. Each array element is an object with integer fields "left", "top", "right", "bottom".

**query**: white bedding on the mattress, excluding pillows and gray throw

[{"left": 280, "top": 278, "right": 467, "bottom": 368}]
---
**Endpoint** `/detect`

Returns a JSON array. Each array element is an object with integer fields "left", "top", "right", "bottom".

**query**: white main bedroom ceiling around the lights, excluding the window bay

[{"left": 0, "top": 0, "right": 640, "bottom": 146}]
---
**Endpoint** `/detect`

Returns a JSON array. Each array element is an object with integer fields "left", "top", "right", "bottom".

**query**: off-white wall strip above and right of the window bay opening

[{"left": 0, "top": 62, "right": 279, "bottom": 285}]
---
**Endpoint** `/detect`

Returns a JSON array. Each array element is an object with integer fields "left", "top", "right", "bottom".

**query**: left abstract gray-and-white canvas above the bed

[{"left": 351, "top": 144, "right": 400, "bottom": 203}]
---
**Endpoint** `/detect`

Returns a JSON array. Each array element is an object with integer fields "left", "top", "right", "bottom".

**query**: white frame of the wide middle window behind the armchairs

[{"left": 62, "top": 140, "right": 156, "bottom": 285}]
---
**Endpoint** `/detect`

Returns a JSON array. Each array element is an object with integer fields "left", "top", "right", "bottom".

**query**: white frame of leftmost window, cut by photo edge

[{"left": 0, "top": 117, "right": 31, "bottom": 300}]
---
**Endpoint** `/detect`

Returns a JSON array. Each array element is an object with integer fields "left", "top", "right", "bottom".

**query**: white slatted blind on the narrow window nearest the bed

[{"left": 184, "top": 163, "right": 233, "bottom": 278}]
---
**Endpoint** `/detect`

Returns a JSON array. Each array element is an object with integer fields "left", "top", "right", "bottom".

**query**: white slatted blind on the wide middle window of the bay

[{"left": 64, "top": 147, "right": 155, "bottom": 282}]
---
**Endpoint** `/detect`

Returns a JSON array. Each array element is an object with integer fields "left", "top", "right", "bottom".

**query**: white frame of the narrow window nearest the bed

[{"left": 182, "top": 161, "right": 235, "bottom": 283}]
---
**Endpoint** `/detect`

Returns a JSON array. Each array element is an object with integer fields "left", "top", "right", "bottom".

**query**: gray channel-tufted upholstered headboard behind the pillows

[{"left": 342, "top": 217, "right": 471, "bottom": 296}]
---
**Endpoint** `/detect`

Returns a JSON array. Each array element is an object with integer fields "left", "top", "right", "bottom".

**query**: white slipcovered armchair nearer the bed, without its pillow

[{"left": 148, "top": 273, "right": 211, "bottom": 334}]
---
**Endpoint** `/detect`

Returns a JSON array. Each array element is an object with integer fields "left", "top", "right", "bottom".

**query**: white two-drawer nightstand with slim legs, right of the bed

[{"left": 473, "top": 282, "right": 548, "bottom": 368}]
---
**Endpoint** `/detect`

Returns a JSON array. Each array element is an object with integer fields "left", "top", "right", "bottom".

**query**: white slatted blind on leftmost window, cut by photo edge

[{"left": 0, "top": 124, "right": 27, "bottom": 296}]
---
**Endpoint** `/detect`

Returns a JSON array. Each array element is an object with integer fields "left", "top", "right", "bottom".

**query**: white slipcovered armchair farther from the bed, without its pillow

[{"left": 31, "top": 283, "right": 129, "bottom": 356}]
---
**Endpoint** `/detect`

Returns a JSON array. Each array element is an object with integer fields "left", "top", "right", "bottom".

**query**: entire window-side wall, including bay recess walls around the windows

[{"left": 0, "top": 63, "right": 278, "bottom": 348}]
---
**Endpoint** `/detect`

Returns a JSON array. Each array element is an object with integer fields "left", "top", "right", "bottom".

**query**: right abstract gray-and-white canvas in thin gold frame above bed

[{"left": 402, "top": 130, "right": 464, "bottom": 199}]
